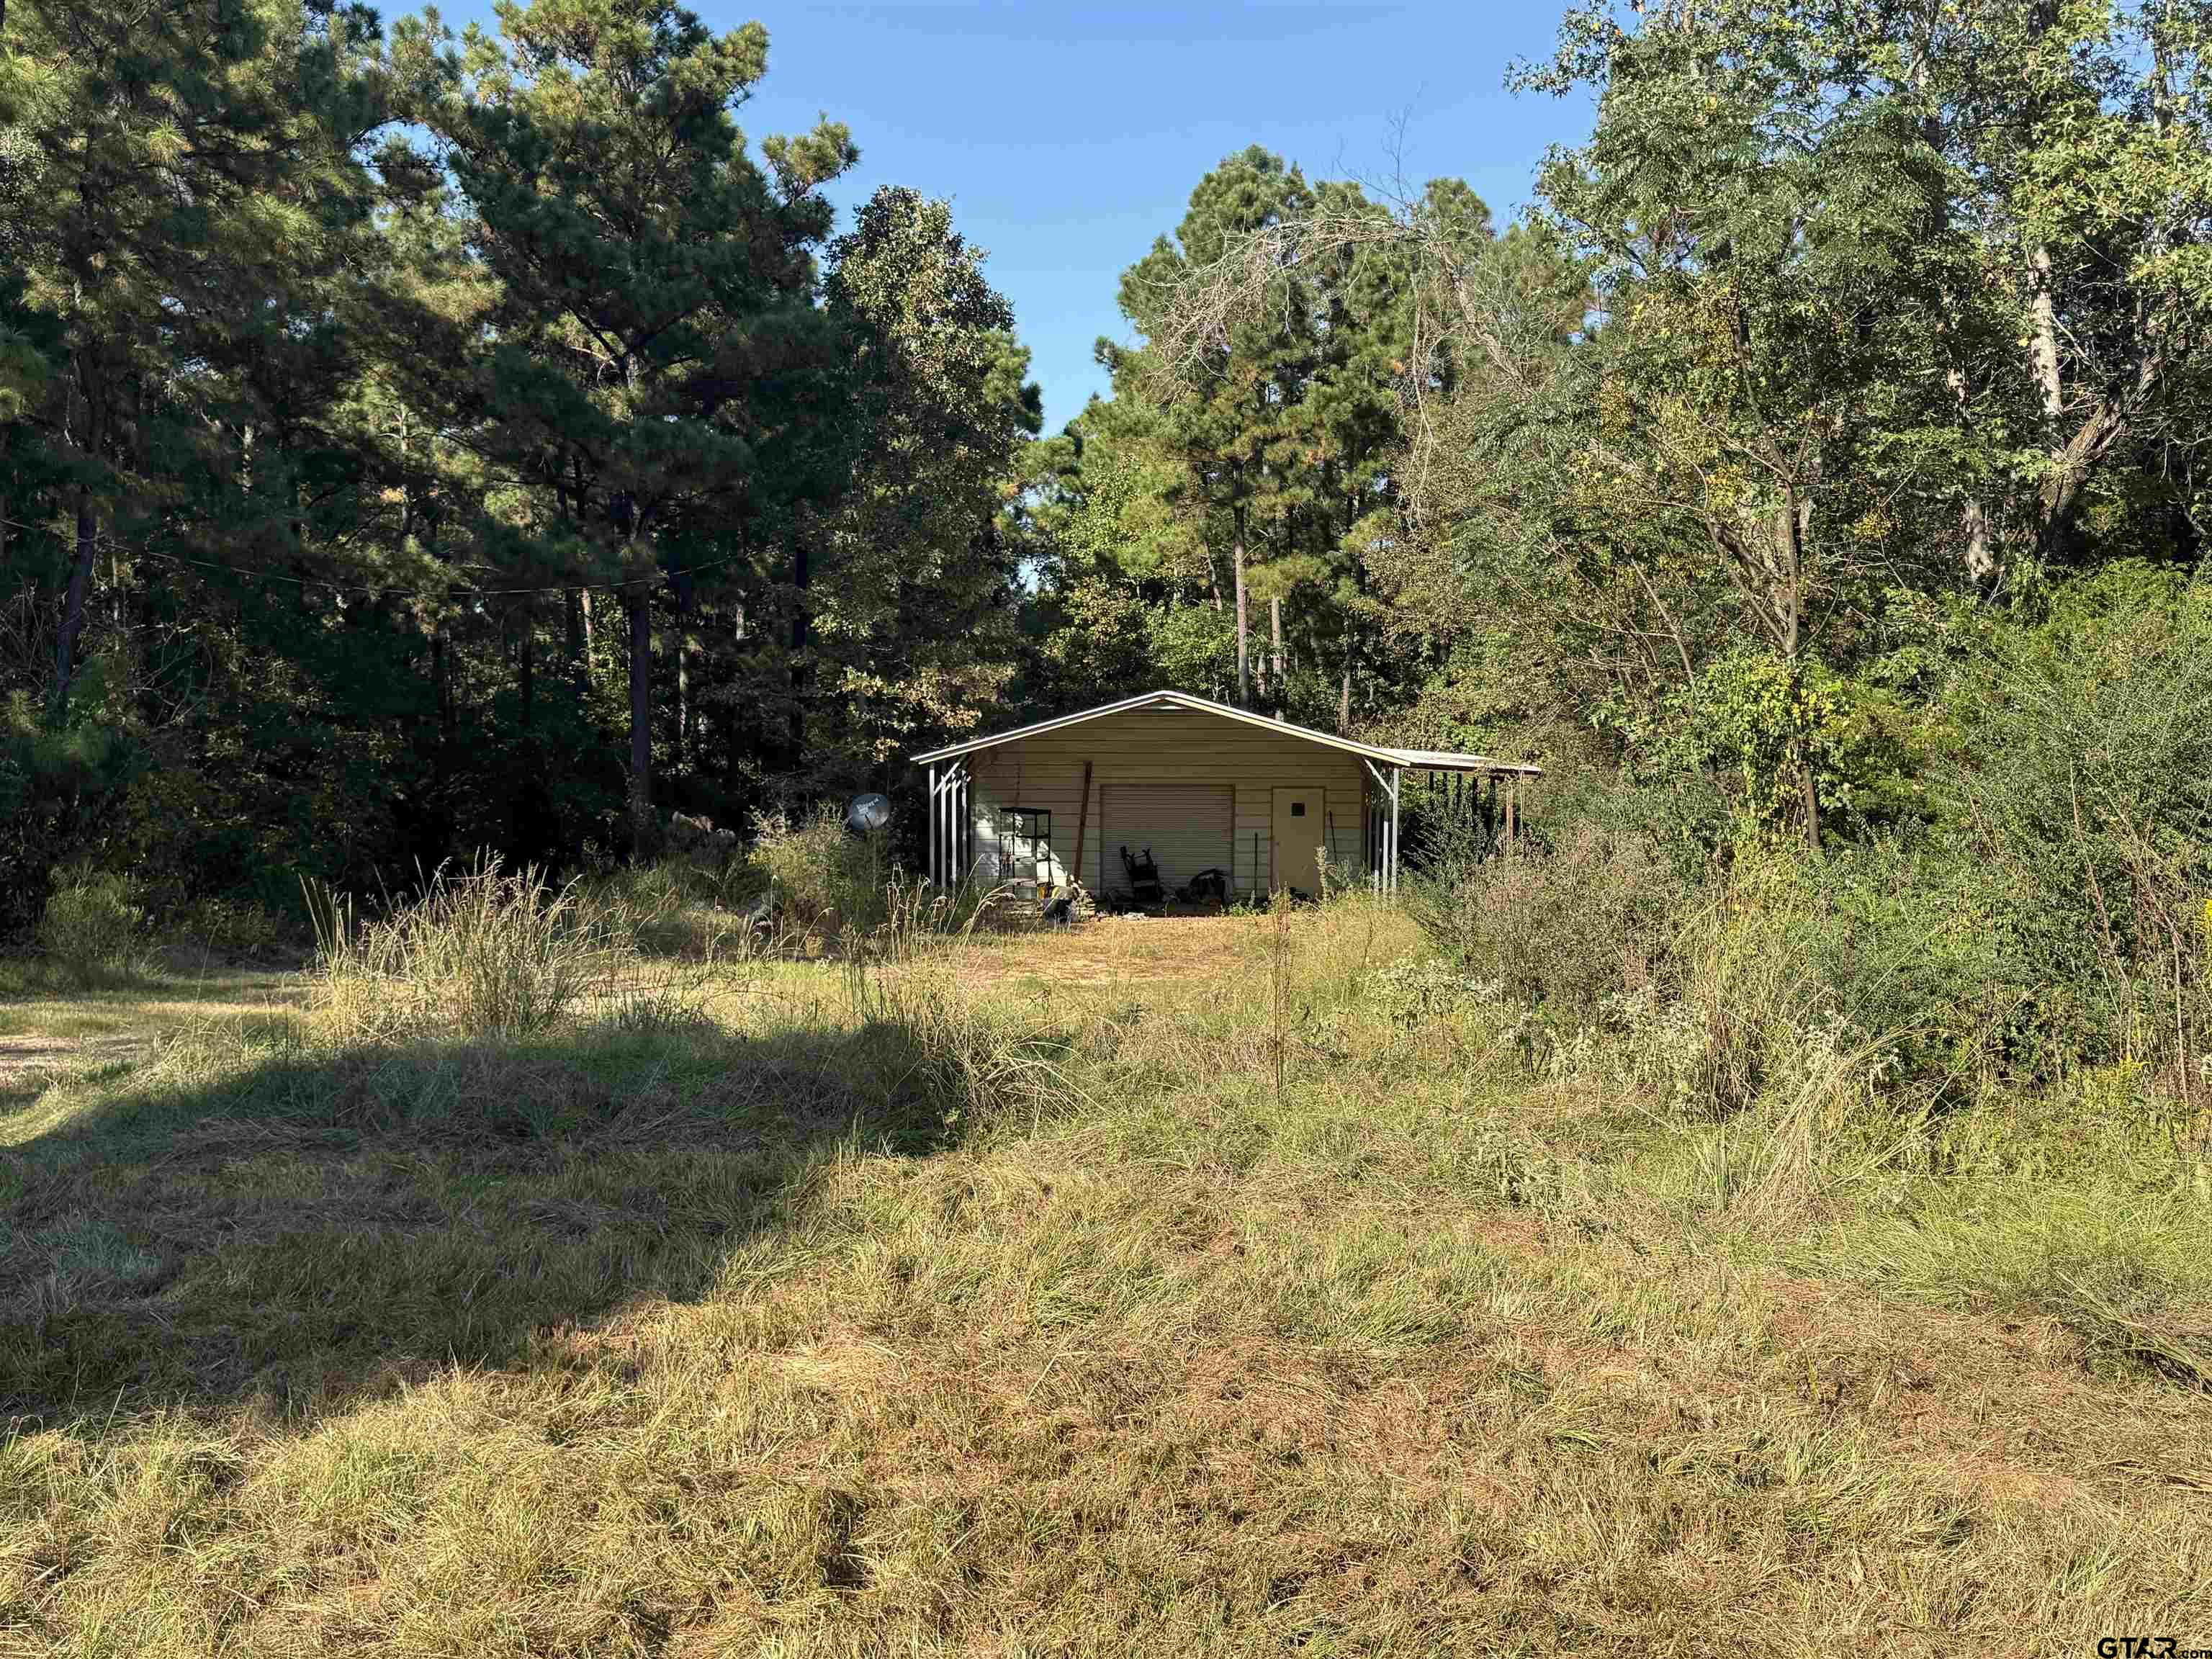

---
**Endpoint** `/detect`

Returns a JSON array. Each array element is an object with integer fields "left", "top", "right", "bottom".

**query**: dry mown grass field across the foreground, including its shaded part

[{"left": 0, "top": 902, "right": 2212, "bottom": 1657}]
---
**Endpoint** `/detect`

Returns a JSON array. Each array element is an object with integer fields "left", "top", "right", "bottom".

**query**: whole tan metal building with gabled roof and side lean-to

[{"left": 914, "top": 693, "right": 1537, "bottom": 894}]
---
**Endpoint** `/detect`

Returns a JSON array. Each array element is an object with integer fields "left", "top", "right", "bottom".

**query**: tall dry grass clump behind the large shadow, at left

[{"left": 310, "top": 856, "right": 619, "bottom": 1042}]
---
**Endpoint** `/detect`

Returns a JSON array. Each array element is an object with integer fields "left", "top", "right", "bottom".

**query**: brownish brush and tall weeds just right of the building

[{"left": 1401, "top": 788, "right": 1928, "bottom": 1135}]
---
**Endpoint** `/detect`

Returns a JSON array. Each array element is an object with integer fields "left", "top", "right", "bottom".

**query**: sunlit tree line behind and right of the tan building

[{"left": 1040, "top": 0, "right": 2212, "bottom": 848}]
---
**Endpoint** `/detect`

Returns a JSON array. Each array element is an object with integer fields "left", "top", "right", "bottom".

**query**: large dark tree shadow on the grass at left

[{"left": 0, "top": 1022, "right": 1004, "bottom": 1429}]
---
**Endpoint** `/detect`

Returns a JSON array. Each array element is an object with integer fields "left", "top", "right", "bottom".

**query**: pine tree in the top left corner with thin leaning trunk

[{"left": 0, "top": 0, "right": 380, "bottom": 721}]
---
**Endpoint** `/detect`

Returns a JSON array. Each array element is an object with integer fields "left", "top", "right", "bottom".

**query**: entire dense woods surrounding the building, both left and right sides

[{"left": 0, "top": 0, "right": 2212, "bottom": 1106}]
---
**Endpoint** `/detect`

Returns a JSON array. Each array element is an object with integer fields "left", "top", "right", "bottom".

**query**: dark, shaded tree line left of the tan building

[{"left": 0, "top": 0, "right": 1040, "bottom": 938}]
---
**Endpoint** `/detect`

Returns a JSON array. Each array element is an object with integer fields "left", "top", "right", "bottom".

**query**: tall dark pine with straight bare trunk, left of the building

[{"left": 400, "top": 0, "right": 856, "bottom": 854}]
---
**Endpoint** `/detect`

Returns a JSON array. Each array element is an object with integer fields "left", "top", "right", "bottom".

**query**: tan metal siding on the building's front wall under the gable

[{"left": 969, "top": 710, "right": 1367, "bottom": 894}]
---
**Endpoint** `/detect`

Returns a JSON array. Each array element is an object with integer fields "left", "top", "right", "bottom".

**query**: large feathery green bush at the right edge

[{"left": 1942, "top": 566, "right": 2212, "bottom": 1097}]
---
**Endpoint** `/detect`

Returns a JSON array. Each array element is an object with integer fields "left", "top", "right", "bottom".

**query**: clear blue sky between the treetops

[{"left": 449, "top": 0, "right": 1591, "bottom": 431}]
